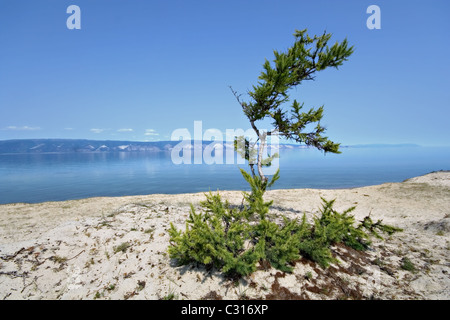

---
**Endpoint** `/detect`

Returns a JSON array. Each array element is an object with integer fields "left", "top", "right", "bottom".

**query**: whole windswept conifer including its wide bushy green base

[{"left": 169, "top": 30, "right": 401, "bottom": 275}]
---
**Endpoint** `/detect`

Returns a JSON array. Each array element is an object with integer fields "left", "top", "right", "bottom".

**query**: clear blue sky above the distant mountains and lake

[{"left": 0, "top": 0, "right": 450, "bottom": 146}]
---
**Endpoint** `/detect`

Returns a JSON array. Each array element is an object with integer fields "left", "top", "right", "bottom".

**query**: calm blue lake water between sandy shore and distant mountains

[{"left": 0, "top": 147, "right": 450, "bottom": 203}]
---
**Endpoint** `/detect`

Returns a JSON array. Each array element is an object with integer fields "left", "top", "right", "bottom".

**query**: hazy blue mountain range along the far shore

[{"left": 0, "top": 139, "right": 417, "bottom": 154}]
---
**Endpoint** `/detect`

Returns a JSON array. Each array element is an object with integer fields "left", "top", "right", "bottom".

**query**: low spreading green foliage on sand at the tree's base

[{"left": 169, "top": 170, "right": 401, "bottom": 276}]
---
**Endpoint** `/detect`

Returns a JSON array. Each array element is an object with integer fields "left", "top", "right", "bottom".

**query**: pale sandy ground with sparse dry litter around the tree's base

[{"left": 0, "top": 172, "right": 450, "bottom": 300}]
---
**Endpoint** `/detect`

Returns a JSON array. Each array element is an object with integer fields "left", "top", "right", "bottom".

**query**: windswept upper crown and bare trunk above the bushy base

[{"left": 230, "top": 29, "right": 353, "bottom": 182}]
